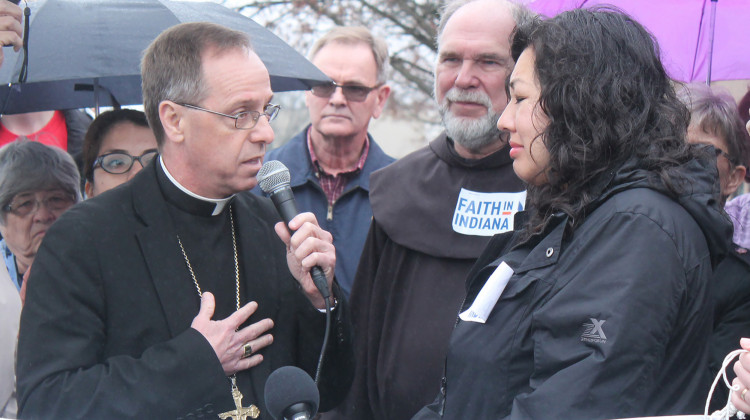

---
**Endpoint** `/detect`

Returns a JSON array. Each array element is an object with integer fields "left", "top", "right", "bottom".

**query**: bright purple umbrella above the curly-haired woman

[{"left": 525, "top": 0, "right": 750, "bottom": 83}]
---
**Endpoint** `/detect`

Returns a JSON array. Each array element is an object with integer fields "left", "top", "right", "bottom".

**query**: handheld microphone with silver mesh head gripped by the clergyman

[{"left": 257, "top": 160, "right": 331, "bottom": 301}]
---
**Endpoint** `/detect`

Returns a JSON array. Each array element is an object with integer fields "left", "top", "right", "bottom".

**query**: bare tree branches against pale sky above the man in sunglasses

[{"left": 236, "top": 0, "right": 441, "bottom": 123}]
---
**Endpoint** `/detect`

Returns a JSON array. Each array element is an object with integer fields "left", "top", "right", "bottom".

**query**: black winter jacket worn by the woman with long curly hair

[{"left": 415, "top": 160, "right": 731, "bottom": 420}]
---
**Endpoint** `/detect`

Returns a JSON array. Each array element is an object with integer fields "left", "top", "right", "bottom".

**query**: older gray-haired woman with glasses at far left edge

[{"left": 0, "top": 138, "right": 81, "bottom": 417}]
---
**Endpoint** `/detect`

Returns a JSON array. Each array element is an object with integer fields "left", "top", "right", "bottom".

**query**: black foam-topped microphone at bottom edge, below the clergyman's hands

[{"left": 263, "top": 366, "right": 320, "bottom": 420}]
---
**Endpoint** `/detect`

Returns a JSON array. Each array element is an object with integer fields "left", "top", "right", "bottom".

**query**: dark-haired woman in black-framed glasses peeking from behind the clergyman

[{"left": 83, "top": 109, "right": 158, "bottom": 198}]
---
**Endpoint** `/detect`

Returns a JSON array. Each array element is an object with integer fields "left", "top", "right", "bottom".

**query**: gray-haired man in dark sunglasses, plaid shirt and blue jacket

[{"left": 256, "top": 27, "right": 393, "bottom": 296}]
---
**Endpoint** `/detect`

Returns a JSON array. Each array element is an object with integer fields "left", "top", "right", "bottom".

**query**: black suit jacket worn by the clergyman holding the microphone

[{"left": 18, "top": 160, "right": 352, "bottom": 419}]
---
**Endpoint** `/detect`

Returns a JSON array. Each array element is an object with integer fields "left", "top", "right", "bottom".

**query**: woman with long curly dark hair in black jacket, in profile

[{"left": 416, "top": 9, "right": 731, "bottom": 420}]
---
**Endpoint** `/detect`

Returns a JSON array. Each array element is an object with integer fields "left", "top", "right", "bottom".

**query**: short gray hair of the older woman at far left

[{"left": 0, "top": 138, "right": 81, "bottom": 224}]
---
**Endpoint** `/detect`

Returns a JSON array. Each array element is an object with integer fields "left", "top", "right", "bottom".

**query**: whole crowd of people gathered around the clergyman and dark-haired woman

[{"left": 0, "top": 0, "right": 750, "bottom": 420}]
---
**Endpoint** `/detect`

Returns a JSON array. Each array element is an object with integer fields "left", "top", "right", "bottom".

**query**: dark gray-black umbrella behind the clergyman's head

[{"left": 0, "top": 0, "right": 329, "bottom": 114}]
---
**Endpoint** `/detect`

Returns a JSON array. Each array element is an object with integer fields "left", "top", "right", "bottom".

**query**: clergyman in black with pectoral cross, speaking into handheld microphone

[{"left": 18, "top": 23, "right": 352, "bottom": 419}]
